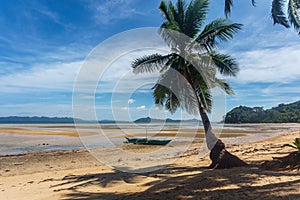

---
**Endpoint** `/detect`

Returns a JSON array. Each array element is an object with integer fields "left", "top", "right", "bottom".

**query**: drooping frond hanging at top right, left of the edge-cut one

[{"left": 271, "top": 0, "right": 290, "bottom": 28}]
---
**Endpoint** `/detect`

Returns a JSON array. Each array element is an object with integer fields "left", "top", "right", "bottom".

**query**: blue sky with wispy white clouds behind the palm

[{"left": 0, "top": 0, "right": 300, "bottom": 120}]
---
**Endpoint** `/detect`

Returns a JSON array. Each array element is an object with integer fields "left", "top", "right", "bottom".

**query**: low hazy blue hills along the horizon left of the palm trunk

[{"left": 0, "top": 116, "right": 200, "bottom": 124}]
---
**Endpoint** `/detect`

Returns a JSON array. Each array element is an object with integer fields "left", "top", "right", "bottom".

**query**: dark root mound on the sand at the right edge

[{"left": 261, "top": 151, "right": 300, "bottom": 170}]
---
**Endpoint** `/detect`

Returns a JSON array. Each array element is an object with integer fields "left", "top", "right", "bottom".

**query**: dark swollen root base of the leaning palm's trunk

[{"left": 208, "top": 139, "right": 248, "bottom": 169}]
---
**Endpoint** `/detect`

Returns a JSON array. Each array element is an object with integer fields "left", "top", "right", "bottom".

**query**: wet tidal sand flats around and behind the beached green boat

[{"left": 0, "top": 124, "right": 300, "bottom": 156}]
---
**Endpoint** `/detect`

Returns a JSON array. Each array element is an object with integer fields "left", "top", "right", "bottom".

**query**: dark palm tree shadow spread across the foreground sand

[{"left": 56, "top": 166, "right": 300, "bottom": 200}]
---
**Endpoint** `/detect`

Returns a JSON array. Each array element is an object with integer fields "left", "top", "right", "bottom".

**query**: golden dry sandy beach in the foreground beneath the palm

[{"left": 0, "top": 124, "right": 300, "bottom": 200}]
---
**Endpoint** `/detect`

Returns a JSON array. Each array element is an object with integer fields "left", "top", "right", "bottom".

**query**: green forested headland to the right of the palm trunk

[{"left": 225, "top": 101, "right": 300, "bottom": 123}]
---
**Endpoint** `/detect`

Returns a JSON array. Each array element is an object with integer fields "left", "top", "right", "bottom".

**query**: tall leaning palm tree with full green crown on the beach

[{"left": 132, "top": 0, "right": 245, "bottom": 168}]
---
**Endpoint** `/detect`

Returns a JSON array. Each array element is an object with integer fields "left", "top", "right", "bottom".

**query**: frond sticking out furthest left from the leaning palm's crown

[{"left": 131, "top": 54, "right": 172, "bottom": 74}]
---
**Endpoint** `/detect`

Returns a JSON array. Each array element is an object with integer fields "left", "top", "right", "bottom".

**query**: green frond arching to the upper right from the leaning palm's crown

[{"left": 195, "top": 18, "right": 242, "bottom": 51}]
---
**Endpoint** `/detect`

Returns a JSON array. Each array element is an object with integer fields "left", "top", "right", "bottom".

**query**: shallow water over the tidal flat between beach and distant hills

[{"left": 0, "top": 123, "right": 300, "bottom": 156}]
